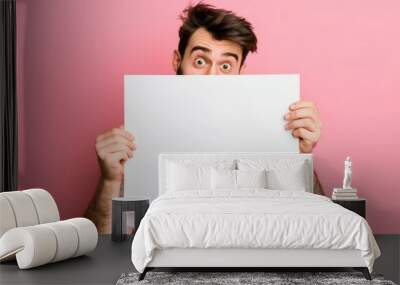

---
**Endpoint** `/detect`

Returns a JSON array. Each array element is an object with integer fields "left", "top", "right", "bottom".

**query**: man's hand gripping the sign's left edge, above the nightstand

[{"left": 96, "top": 126, "right": 136, "bottom": 182}]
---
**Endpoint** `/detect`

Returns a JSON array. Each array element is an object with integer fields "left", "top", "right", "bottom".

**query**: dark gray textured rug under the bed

[{"left": 117, "top": 271, "right": 395, "bottom": 285}]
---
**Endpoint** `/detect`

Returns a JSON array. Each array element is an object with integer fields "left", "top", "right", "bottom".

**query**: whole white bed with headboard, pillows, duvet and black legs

[{"left": 131, "top": 153, "right": 380, "bottom": 280}]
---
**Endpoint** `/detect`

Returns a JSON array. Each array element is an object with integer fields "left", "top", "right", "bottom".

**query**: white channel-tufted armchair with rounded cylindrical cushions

[{"left": 0, "top": 189, "right": 98, "bottom": 269}]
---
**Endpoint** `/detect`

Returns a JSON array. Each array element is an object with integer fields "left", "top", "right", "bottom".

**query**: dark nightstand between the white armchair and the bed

[{"left": 111, "top": 197, "right": 150, "bottom": 241}]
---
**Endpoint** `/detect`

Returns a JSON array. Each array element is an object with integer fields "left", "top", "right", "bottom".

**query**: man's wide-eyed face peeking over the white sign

[{"left": 173, "top": 28, "right": 244, "bottom": 75}]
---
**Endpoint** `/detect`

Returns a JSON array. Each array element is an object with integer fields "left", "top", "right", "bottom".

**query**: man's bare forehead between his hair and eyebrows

[{"left": 187, "top": 28, "right": 242, "bottom": 58}]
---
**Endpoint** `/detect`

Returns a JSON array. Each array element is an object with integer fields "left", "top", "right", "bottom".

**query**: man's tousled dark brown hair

[{"left": 178, "top": 2, "right": 257, "bottom": 64}]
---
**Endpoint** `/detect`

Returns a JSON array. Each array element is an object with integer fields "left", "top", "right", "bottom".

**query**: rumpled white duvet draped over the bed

[{"left": 132, "top": 189, "right": 380, "bottom": 272}]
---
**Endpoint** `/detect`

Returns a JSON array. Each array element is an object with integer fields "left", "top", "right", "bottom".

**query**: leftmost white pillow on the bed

[{"left": 167, "top": 162, "right": 211, "bottom": 191}]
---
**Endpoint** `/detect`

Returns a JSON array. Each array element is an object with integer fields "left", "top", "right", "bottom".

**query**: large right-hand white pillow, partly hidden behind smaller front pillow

[{"left": 238, "top": 159, "right": 308, "bottom": 191}]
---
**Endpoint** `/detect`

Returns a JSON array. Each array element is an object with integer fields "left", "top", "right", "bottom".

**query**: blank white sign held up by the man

[{"left": 124, "top": 74, "right": 300, "bottom": 196}]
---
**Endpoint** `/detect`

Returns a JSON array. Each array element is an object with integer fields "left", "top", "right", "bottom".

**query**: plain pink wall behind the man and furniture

[{"left": 17, "top": 0, "right": 400, "bottom": 234}]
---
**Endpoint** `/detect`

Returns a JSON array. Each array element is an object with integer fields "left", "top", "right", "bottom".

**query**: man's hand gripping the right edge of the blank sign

[{"left": 285, "top": 101, "right": 322, "bottom": 153}]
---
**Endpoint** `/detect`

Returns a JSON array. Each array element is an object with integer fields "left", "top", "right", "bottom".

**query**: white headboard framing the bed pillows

[{"left": 158, "top": 152, "right": 314, "bottom": 195}]
